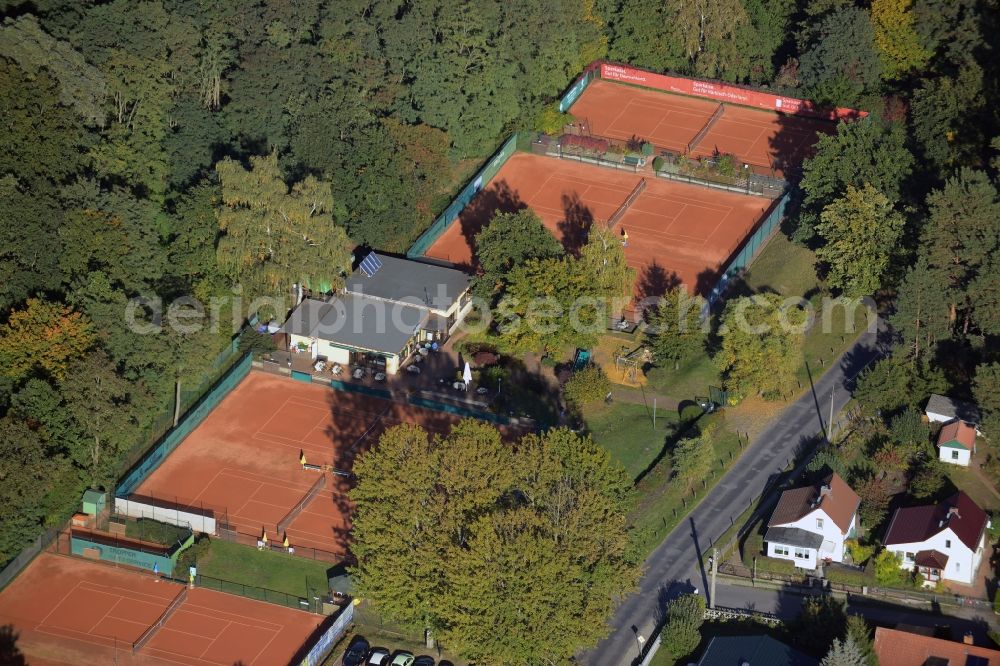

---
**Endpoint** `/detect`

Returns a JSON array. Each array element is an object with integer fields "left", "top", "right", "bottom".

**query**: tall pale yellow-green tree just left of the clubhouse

[{"left": 216, "top": 153, "right": 351, "bottom": 315}]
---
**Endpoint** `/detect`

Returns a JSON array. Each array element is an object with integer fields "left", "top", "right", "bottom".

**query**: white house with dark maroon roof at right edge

[{"left": 885, "top": 491, "right": 990, "bottom": 585}]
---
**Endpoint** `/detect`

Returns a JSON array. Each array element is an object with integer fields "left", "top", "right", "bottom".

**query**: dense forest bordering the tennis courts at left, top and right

[{"left": 0, "top": 0, "right": 1000, "bottom": 562}]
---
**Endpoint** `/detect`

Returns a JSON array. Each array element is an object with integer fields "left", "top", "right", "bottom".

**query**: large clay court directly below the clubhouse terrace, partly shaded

[{"left": 135, "top": 372, "right": 459, "bottom": 556}]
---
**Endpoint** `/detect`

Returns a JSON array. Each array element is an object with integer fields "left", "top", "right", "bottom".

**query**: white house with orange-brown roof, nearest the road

[{"left": 764, "top": 473, "right": 861, "bottom": 569}]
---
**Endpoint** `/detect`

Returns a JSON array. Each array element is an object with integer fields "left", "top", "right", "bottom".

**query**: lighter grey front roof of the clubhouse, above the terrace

[{"left": 281, "top": 294, "right": 429, "bottom": 354}]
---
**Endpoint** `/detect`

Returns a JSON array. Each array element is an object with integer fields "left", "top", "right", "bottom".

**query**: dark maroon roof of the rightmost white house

[{"left": 885, "top": 491, "right": 987, "bottom": 550}]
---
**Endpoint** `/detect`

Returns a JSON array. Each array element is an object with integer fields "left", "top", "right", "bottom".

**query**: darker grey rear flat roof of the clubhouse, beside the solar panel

[{"left": 344, "top": 253, "right": 472, "bottom": 310}]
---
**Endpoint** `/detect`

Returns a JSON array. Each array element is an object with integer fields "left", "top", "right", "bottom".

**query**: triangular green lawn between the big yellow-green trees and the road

[{"left": 585, "top": 401, "right": 677, "bottom": 479}]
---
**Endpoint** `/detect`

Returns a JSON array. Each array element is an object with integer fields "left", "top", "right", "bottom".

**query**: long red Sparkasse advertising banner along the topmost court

[{"left": 601, "top": 63, "right": 868, "bottom": 120}]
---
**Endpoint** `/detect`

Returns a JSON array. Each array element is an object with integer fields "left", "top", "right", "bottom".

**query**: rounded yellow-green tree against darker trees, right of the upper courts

[{"left": 816, "top": 183, "right": 905, "bottom": 298}]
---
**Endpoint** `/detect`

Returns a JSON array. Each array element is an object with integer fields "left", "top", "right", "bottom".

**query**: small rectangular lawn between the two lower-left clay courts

[{"left": 198, "top": 539, "right": 330, "bottom": 597}]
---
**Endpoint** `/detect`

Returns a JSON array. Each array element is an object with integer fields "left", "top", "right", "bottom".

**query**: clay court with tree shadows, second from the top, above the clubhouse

[{"left": 427, "top": 153, "right": 774, "bottom": 296}]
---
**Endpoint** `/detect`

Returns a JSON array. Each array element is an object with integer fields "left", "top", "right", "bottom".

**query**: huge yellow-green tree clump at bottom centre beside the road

[{"left": 351, "top": 421, "right": 636, "bottom": 663}]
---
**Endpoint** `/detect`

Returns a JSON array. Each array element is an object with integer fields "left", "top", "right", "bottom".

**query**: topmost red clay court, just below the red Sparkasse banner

[{"left": 570, "top": 79, "right": 837, "bottom": 173}]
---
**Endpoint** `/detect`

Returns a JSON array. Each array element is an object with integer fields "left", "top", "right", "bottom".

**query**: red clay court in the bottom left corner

[{"left": 0, "top": 553, "right": 323, "bottom": 666}]
